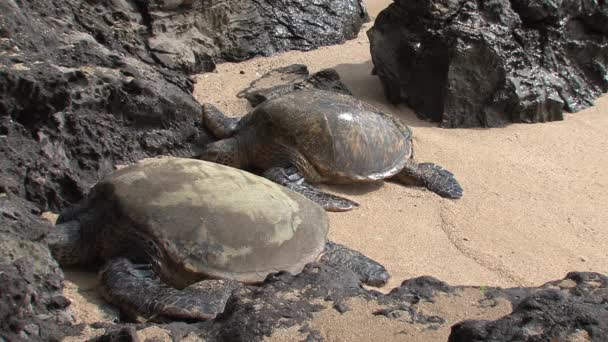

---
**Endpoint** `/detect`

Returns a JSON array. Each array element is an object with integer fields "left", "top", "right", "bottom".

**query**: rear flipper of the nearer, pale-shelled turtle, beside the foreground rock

[{"left": 318, "top": 241, "right": 391, "bottom": 287}]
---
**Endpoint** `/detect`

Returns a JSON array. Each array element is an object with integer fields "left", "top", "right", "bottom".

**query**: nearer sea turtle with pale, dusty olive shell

[{"left": 47, "top": 157, "right": 389, "bottom": 320}]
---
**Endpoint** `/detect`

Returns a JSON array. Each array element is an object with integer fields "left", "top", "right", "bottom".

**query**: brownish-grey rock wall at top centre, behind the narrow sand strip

[{"left": 146, "top": 0, "right": 369, "bottom": 72}]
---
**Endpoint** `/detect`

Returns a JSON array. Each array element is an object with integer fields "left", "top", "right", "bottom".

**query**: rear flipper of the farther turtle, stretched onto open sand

[{"left": 393, "top": 161, "right": 464, "bottom": 199}]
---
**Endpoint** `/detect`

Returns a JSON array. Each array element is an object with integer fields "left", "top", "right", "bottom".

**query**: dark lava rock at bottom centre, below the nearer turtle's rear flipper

[{"left": 206, "top": 263, "right": 372, "bottom": 341}]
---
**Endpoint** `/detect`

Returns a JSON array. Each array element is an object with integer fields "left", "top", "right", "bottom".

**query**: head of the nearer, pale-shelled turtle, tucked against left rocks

[{"left": 45, "top": 221, "right": 87, "bottom": 266}]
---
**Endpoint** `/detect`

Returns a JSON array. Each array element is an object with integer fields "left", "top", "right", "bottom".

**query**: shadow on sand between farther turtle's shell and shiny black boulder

[{"left": 332, "top": 60, "right": 439, "bottom": 127}]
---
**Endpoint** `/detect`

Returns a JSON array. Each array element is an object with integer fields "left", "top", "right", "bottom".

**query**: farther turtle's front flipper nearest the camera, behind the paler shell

[{"left": 264, "top": 167, "right": 359, "bottom": 211}]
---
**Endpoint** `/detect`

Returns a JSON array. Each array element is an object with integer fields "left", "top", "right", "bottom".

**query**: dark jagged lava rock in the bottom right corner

[{"left": 449, "top": 272, "right": 608, "bottom": 342}]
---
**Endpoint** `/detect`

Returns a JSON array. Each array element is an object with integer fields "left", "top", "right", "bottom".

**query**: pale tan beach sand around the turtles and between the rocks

[{"left": 59, "top": 0, "right": 608, "bottom": 341}]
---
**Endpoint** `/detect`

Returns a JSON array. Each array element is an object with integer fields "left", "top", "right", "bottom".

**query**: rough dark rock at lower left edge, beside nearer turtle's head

[{"left": 0, "top": 194, "right": 80, "bottom": 341}]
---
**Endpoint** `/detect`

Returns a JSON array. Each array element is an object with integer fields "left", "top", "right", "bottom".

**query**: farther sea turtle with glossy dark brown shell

[{"left": 200, "top": 89, "right": 463, "bottom": 211}]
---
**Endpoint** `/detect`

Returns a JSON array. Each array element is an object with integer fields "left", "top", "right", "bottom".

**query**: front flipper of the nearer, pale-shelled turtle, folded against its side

[{"left": 100, "top": 258, "right": 240, "bottom": 321}]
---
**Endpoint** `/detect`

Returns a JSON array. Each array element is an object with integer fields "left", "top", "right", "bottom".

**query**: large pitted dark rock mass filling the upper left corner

[{"left": 0, "top": 0, "right": 205, "bottom": 211}]
